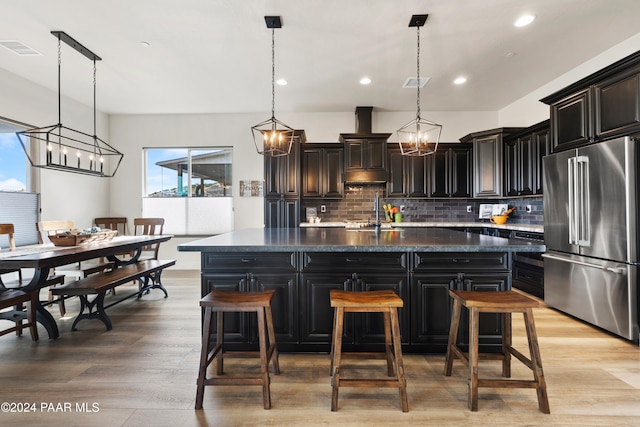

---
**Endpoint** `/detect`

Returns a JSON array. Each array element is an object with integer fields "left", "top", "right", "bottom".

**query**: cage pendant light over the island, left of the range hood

[{"left": 251, "top": 16, "right": 295, "bottom": 157}]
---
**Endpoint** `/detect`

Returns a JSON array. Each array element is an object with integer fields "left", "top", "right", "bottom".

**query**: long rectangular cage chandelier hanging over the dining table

[{"left": 16, "top": 31, "right": 123, "bottom": 178}]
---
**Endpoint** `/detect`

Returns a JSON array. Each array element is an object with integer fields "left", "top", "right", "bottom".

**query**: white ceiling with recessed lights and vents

[{"left": 0, "top": 0, "right": 640, "bottom": 114}]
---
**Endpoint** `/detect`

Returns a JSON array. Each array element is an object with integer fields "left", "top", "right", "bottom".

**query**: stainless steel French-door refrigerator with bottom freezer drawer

[{"left": 543, "top": 137, "right": 640, "bottom": 342}]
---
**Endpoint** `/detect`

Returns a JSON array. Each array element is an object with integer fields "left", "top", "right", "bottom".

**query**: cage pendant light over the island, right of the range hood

[{"left": 396, "top": 15, "right": 442, "bottom": 156}]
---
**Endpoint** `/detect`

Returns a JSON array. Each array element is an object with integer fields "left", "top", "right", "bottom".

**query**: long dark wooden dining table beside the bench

[{"left": 0, "top": 235, "right": 173, "bottom": 339}]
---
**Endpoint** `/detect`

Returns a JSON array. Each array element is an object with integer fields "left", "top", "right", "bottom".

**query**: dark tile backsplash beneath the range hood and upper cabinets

[{"left": 302, "top": 184, "right": 543, "bottom": 225}]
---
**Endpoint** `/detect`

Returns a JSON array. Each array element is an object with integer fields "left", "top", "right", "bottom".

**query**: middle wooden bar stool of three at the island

[{"left": 331, "top": 290, "right": 409, "bottom": 412}]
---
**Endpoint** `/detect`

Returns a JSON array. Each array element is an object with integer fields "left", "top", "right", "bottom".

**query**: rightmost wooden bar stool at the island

[{"left": 444, "top": 291, "right": 550, "bottom": 414}]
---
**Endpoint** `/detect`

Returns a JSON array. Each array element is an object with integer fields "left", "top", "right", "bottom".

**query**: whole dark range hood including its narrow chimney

[{"left": 340, "top": 107, "right": 391, "bottom": 184}]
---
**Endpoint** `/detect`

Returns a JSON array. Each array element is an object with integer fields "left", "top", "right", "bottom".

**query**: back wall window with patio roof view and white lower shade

[{"left": 142, "top": 147, "right": 233, "bottom": 235}]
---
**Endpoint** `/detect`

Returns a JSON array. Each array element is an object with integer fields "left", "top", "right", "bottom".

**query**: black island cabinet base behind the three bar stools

[{"left": 202, "top": 252, "right": 512, "bottom": 353}]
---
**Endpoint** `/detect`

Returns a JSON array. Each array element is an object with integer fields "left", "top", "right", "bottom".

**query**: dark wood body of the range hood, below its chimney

[{"left": 340, "top": 133, "right": 391, "bottom": 182}]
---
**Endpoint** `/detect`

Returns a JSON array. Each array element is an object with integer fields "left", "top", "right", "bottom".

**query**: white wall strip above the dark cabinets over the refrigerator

[{"left": 498, "top": 33, "right": 640, "bottom": 127}]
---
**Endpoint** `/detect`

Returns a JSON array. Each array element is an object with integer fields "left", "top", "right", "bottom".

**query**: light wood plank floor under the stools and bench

[{"left": 0, "top": 270, "right": 640, "bottom": 426}]
